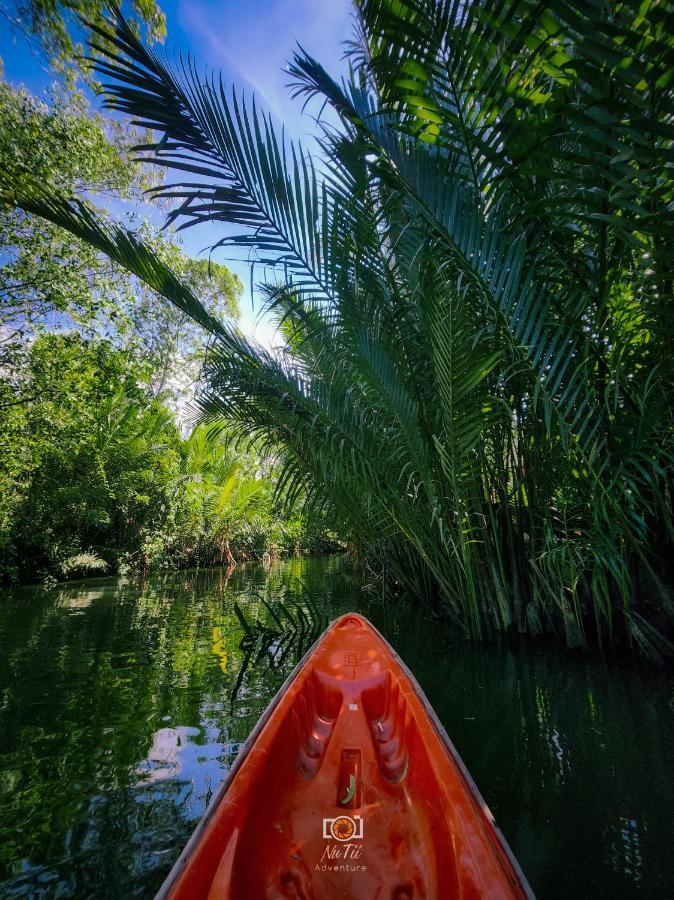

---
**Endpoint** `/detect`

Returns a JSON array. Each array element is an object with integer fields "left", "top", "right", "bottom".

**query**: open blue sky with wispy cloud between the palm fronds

[{"left": 0, "top": 0, "right": 352, "bottom": 345}]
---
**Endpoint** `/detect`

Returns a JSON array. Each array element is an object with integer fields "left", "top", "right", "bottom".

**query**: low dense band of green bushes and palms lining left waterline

[{"left": 0, "top": 334, "right": 330, "bottom": 580}]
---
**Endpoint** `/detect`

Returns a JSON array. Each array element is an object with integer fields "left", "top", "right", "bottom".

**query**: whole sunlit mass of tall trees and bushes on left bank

[{"left": 0, "top": 72, "right": 334, "bottom": 582}]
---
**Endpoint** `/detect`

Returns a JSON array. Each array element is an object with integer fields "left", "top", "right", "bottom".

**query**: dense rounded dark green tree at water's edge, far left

[{"left": 0, "top": 334, "right": 180, "bottom": 576}]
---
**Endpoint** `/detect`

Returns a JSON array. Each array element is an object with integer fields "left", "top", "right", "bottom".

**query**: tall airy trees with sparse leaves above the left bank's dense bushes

[{"left": 0, "top": 82, "right": 242, "bottom": 402}]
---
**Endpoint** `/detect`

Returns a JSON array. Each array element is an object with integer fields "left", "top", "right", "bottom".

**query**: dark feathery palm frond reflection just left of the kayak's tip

[{"left": 231, "top": 595, "right": 329, "bottom": 712}]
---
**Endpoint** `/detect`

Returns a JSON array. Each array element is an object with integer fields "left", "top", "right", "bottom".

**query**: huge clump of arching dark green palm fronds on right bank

[{"left": 3, "top": 0, "right": 674, "bottom": 658}]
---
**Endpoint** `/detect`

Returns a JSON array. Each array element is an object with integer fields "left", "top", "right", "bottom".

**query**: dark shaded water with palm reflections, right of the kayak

[{"left": 378, "top": 614, "right": 674, "bottom": 898}]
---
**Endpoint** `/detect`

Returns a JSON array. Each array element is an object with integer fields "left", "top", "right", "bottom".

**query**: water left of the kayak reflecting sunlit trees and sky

[{"left": 0, "top": 557, "right": 344, "bottom": 896}]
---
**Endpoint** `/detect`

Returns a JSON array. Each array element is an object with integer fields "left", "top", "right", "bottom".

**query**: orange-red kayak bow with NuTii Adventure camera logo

[{"left": 157, "top": 613, "right": 533, "bottom": 900}]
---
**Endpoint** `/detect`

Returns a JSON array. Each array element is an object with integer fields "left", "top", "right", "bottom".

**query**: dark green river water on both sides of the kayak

[{"left": 0, "top": 558, "right": 674, "bottom": 900}]
